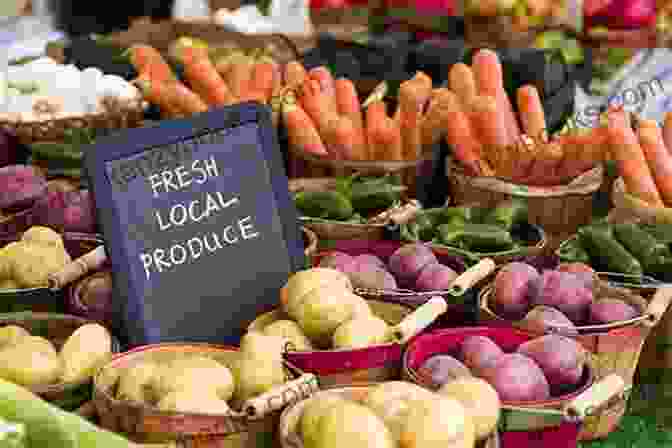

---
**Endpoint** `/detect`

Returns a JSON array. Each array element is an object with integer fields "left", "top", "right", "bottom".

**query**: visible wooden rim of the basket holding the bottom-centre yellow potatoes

[{"left": 278, "top": 385, "right": 499, "bottom": 448}]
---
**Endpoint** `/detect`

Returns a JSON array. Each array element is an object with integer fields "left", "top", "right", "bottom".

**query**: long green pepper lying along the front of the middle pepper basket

[{"left": 438, "top": 224, "right": 514, "bottom": 252}]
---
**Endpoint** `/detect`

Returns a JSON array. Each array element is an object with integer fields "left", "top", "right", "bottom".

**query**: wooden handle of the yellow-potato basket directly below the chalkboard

[{"left": 242, "top": 373, "right": 320, "bottom": 420}]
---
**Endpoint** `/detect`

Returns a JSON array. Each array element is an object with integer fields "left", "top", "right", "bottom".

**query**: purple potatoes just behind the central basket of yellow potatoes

[{"left": 320, "top": 243, "right": 458, "bottom": 291}]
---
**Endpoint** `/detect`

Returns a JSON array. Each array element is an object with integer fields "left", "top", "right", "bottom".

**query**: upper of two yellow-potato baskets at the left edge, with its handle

[{"left": 0, "top": 226, "right": 103, "bottom": 313}]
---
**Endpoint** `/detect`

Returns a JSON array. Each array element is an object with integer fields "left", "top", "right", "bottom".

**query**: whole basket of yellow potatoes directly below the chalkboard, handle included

[{"left": 93, "top": 340, "right": 318, "bottom": 447}]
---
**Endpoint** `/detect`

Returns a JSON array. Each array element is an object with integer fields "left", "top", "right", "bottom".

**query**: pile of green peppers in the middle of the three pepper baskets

[{"left": 400, "top": 200, "right": 527, "bottom": 253}]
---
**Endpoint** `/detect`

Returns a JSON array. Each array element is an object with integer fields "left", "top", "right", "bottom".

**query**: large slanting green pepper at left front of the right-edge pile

[{"left": 578, "top": 225, "right": 644, "bottom": 276}]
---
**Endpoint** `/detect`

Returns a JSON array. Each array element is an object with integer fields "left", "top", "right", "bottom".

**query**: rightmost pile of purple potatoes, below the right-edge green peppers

[{"left": 489, "top": 262, "right": 642, "bottom": 326}]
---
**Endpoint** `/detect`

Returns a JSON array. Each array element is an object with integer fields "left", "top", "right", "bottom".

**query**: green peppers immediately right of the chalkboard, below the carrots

[{"left": 294, "top": 174, "right": 406, "bottom": 224}]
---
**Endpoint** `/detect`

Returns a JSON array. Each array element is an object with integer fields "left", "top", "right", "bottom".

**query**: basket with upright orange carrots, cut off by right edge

[{"left": 609, "top": 111, "right": 672, "bottom": 224}]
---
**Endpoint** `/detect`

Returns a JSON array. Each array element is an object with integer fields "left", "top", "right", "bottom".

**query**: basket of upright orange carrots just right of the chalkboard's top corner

[{"left": 281, "top": 62, "right": 440, "bottom": 194}]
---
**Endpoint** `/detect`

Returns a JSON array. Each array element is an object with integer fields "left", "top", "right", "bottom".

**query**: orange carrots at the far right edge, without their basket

[{"left": 608, "top": 110, "right": 672, "bottom": 207}]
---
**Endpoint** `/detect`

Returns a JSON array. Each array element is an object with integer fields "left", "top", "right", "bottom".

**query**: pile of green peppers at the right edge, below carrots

[{"left": 558, "top": 221, "right": 672, "bottom": 281}]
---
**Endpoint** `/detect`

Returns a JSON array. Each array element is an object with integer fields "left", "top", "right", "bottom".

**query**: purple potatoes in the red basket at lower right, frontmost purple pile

[{"left": 418, "top": 334, "right": 587, "bottom": 403}]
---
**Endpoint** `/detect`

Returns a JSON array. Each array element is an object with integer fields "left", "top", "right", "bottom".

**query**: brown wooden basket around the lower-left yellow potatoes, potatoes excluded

[{"left": 0, "top": 312, "right": 120, "bottom": 411}]
